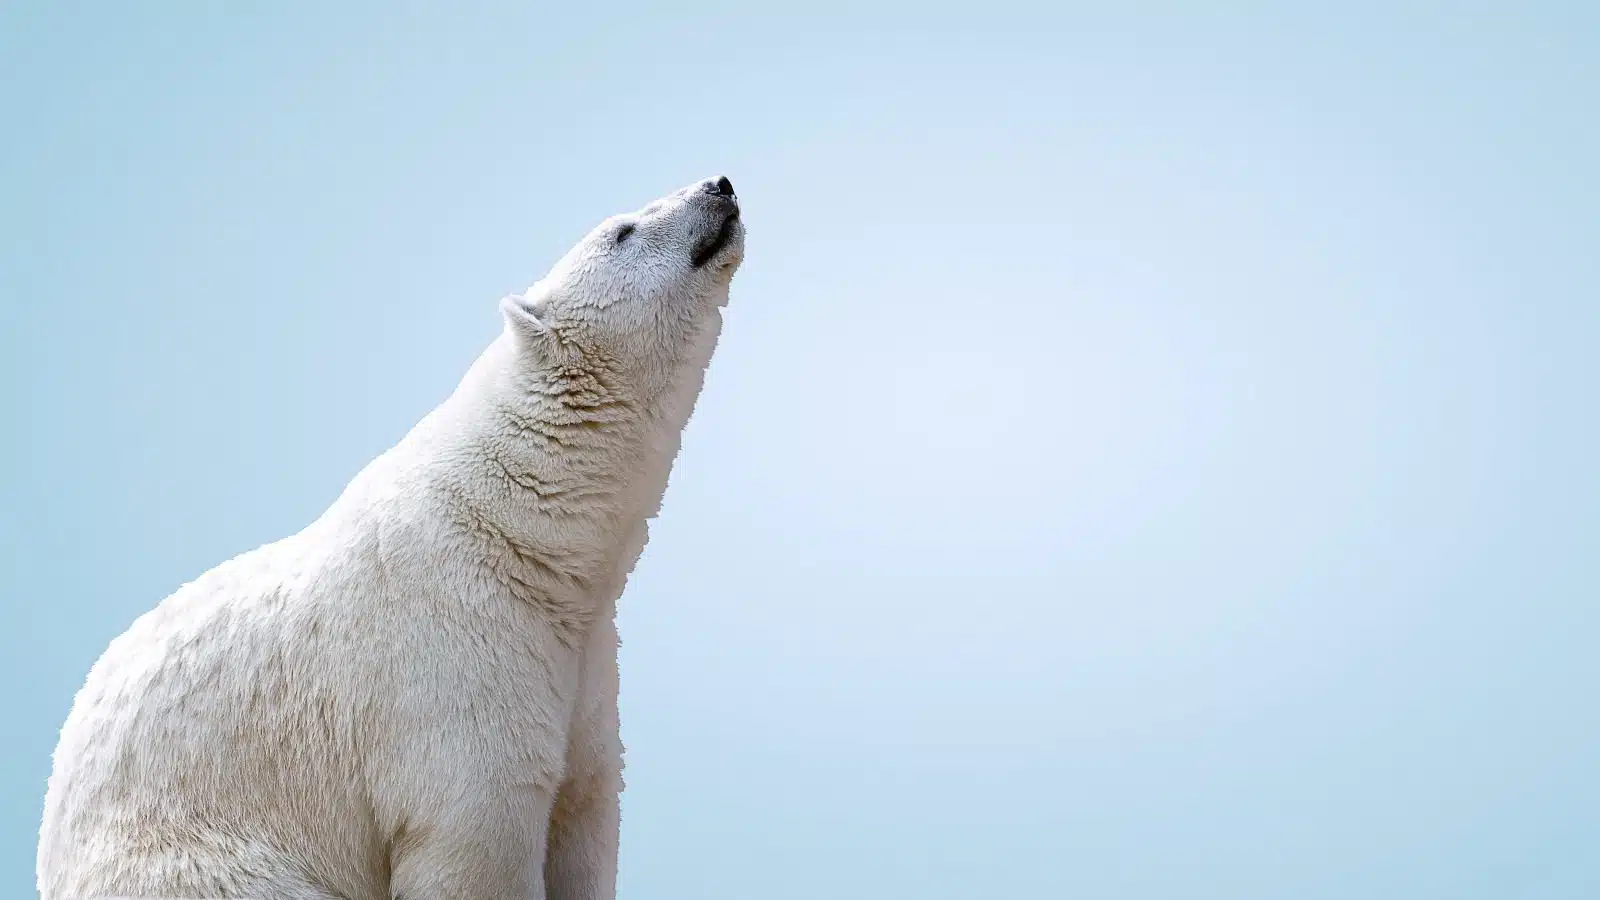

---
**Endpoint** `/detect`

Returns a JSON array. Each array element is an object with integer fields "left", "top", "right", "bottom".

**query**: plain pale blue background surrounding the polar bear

[{"left": 0, "top": 2, "right": 1600, "bottom": 900}]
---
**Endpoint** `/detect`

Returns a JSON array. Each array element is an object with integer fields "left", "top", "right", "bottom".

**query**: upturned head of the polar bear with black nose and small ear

[{"left": 502, "top": 178, "right": 744, "bottom": 396}]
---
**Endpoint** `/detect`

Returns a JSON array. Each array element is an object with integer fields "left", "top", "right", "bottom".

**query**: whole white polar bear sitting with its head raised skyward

[{"left": 38, "top": 178, "right": 744, "bottom": 900}]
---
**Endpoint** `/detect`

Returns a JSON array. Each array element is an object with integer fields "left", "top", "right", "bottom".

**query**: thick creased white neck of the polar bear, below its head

[{"left": 341, "top": 311, "right": 722, "bottom": 629}]
